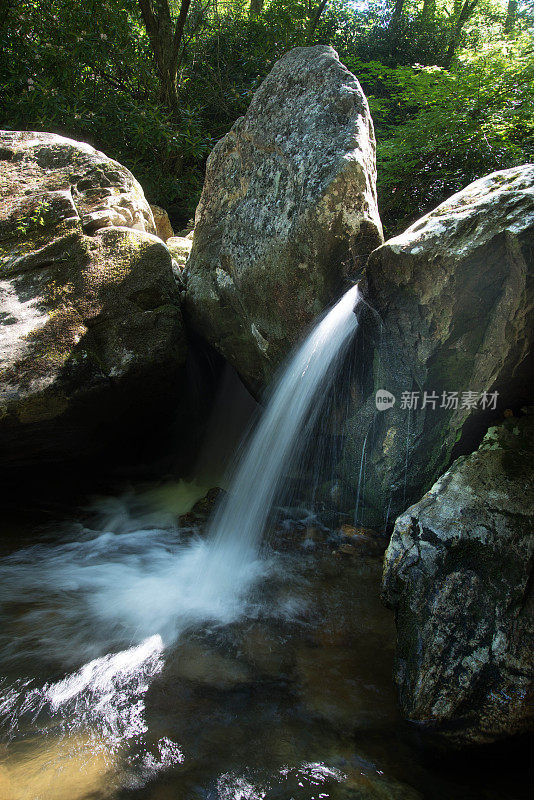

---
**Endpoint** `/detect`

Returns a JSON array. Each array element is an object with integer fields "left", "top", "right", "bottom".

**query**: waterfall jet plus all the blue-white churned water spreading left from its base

[{"left": 0, "top": 286, "right": 363, "bottom": 663}]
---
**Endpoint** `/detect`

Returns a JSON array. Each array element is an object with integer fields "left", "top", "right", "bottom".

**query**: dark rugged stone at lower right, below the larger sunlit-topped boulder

[{"left": 383, "top": 415, "right": 534, "bottom": 744}]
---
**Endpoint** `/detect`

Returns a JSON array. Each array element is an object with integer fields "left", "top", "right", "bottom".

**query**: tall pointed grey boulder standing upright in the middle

[{"left": 186, "top": 45, "right": 382, "bottom": 389}]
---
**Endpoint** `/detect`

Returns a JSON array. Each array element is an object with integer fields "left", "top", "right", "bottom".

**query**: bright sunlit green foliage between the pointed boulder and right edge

[{"left": 351, "top": 35, "right": 534, "bottom": 234}]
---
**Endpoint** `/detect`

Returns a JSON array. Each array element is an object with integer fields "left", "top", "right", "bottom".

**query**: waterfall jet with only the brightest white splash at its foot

[{"left": 104, "top": 286, "right": 363, "bottom": 640}]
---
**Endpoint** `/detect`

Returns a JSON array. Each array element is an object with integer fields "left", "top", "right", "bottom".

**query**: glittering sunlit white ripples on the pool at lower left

[{"left": 0, "top": 636, "right": 184, "bottom": 797}]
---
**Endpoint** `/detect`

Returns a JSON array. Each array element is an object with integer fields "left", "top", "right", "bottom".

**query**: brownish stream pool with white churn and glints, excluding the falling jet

[{"left": 0, "top": 484, "right": 530, "bottom": 800}]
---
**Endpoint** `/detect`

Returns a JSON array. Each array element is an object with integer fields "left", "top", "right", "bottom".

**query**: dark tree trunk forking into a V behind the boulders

[{"left": 139, "top": 0, "right": 191, "bottom": 116}]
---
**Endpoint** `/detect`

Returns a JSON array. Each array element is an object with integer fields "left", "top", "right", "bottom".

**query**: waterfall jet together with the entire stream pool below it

[{"left": 0, "top": 287, "right": 520, "bottom": 800}]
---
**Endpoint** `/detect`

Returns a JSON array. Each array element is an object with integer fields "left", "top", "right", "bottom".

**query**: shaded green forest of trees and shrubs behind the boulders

[{"left": 0, "top": 0, "right": 534, "bottom": 235}]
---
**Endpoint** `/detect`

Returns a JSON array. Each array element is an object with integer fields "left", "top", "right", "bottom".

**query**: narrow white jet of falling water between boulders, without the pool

[{"left": 201, "top": 286, "right": 362, "bottom": 582}]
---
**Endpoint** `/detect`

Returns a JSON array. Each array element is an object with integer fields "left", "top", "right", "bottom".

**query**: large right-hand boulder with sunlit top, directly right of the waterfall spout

[{"left": 342, "top": 164, "right": 534, "bottom": 526}]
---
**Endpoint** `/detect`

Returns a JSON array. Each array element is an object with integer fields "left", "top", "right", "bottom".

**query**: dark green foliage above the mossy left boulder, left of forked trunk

[{"left": 0, "top": 0, "right": 210, "bottom": 219}]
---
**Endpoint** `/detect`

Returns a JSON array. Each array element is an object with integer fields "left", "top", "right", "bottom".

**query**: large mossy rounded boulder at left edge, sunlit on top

[{"left": 0, "top": 131, "right": 185, "bottom": 474}]
